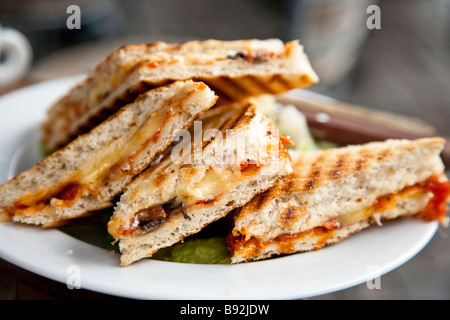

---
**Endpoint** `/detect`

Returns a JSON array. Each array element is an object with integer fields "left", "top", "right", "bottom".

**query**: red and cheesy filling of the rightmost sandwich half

[{"left": 227, "top": 174, "right": 450, "bottom": 259}]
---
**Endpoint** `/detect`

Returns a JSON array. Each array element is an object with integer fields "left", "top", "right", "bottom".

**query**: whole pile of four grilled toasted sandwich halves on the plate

[{"left": 0, "top": 39, "right": 450, "bottom": 266}]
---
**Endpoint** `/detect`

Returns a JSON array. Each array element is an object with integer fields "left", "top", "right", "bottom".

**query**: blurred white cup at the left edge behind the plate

[{"left": 0, "top": 25, "right": 32, "bottom": 86}]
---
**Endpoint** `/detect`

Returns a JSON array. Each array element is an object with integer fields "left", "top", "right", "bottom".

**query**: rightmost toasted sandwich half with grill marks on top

[{"left": 227, "top": 138, "right": 450, "bottom": 263}]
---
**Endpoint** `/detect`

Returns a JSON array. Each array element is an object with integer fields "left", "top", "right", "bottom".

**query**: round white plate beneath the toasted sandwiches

[{"left": 0, "top": 76, "right": 438, "bottom": 299}]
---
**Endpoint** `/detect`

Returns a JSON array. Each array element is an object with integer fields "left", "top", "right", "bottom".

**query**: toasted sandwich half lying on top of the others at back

[{"left": 42, "top": 39, "right": 318, "bottom": 152}]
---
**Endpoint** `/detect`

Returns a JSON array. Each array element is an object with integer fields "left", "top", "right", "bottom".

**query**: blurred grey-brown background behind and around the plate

[{"left": 0, "top": 0, "right": 450, "bottom": 299}]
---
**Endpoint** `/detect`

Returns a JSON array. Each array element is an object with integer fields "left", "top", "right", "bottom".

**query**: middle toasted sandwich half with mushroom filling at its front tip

[{"left": 108, "top": 104, "right": 292, "bottom": 266}]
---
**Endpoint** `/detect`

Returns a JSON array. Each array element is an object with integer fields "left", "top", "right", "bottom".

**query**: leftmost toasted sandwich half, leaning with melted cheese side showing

[{"left": 0, "top": 81, "right": 217, "bottom": 227}]
